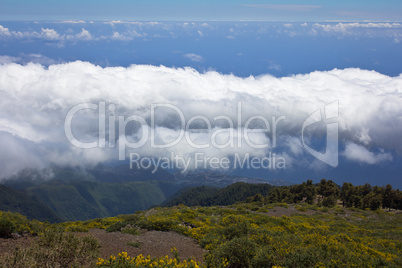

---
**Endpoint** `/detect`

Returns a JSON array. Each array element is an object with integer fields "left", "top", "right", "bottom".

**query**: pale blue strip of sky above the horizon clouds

[{"left": 0, "top": 0, "right": 402, "bottom": 21}]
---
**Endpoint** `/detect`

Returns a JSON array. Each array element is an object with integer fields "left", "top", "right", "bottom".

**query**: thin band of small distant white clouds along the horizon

[{"left": 0, "top": 21, "right": 402, "bottom": 43}]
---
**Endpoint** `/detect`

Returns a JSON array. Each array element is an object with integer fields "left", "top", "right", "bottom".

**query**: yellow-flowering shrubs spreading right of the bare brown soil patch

[{"left": 99, "top": 203, "right": 402, "bottom": 267}]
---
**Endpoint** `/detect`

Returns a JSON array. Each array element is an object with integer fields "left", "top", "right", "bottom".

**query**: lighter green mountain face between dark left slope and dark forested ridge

[{"left": 26, "top": 180, "right": 179, "bottom": 220}]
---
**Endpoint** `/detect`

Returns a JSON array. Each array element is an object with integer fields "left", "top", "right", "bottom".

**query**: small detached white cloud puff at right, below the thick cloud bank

[{"left": 343, "top": 142, "right": 392, "bottom": 165}]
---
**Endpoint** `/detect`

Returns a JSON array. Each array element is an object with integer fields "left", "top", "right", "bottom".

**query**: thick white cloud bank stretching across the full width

[{"left": 0, "top": 60, "right": 402, "bottom": 178}]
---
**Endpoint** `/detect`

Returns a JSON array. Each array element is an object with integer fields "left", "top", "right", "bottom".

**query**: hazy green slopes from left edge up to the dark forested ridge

[{"left": 0, "top": 165, "right": 182, "bottom": 222}]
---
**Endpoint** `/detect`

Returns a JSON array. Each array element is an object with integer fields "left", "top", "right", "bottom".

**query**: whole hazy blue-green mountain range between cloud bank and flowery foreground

[{"left": 0, "top": 165, "right": 287, "bottom": 222}]
